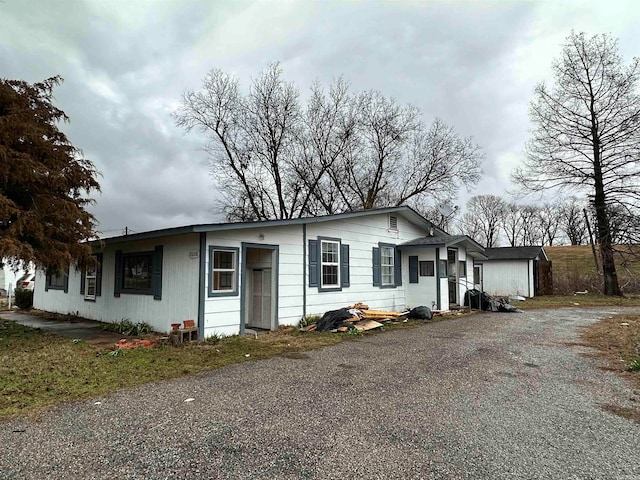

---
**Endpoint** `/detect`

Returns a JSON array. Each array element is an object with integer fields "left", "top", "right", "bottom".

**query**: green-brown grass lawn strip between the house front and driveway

[{"left": 0, "top": 319, "right": 428, "bottom": 420}]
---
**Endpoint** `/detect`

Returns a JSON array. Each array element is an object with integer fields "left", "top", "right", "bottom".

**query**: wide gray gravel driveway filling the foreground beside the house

[{"left": 0, "top": 307, "right": 640, "bottom": 480}]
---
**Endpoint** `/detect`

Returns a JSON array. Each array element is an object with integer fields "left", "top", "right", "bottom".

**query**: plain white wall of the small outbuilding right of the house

[{"left": 483, "top": 260, "right": 533, "bottom": 297}]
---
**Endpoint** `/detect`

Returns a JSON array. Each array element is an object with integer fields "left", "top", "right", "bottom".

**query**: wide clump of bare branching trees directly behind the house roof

[{"left": 174, "top": 63, "right": 483, "bottom": 221}]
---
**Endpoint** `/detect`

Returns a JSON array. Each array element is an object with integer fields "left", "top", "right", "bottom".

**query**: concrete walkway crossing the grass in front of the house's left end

[{"left": 0, "top": 311, "right": 125, "bottom": 343}]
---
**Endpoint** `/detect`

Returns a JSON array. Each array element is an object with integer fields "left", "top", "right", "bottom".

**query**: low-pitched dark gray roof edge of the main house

[{"left": 91, "top": 205, "right": 447, "bottom": 244}]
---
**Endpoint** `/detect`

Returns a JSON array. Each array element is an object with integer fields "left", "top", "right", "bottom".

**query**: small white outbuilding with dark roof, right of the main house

[{"left": 478, "top": 246, "right": 552, "bottom": 298}]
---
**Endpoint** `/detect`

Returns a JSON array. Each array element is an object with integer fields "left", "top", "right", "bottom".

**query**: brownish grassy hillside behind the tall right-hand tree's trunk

[{"left": 544, "top": 245, "right": 640, "bottom": 294}]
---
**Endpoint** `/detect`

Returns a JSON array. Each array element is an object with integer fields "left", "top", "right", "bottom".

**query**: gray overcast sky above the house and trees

[{"left": 0, "top": 0, "right": 640, "bottom": 236}]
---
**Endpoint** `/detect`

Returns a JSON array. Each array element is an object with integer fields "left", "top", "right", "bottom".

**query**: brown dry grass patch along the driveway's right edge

[{"left": 580, "top": 315, "right": 640, "bottom": 423}]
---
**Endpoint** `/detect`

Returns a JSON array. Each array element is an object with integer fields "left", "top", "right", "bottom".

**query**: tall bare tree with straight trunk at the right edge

[{"left": 514, "top": 33, "right": 640, "bottom": 295}]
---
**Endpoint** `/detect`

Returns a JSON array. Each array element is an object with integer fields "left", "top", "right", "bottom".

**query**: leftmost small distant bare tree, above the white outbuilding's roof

[{"left": 460, "top": 195, "right": 507, "bottom": 248}]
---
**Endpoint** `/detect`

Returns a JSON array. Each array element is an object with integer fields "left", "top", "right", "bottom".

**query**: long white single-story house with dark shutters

[{"left": 34, "top": 206, "right": 486, "bottom": 338}]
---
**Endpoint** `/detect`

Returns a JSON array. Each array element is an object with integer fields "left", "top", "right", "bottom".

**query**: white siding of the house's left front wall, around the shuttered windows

[{"left": 34, "top": 234, "right": 199, "bottom": 332}]
